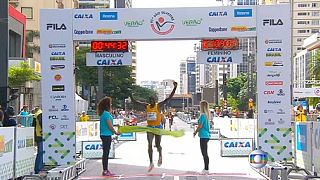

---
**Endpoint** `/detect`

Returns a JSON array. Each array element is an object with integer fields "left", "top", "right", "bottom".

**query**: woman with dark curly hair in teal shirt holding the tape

[{"left": 97, "top": 97, "right": 120, "bottom": 176}]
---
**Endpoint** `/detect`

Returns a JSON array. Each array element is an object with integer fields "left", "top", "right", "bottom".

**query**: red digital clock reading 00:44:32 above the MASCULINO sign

[{"left": 91, "top": 41, "right": 129, "bottom": 52}]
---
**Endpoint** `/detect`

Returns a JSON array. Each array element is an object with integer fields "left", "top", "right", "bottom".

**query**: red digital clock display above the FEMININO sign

[{"left": 201, "top": 38, "right": 239, "bottom": 51}]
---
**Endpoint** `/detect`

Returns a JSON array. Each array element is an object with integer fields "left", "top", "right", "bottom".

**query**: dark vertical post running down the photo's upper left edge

[{"left": 0, "top": 0, "right": 9, "bottom": 109}]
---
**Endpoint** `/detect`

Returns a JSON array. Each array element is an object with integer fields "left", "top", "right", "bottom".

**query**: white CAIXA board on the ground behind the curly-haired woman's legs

[{"left": 82, "top": 141, "right": 115, "bottom": 159}]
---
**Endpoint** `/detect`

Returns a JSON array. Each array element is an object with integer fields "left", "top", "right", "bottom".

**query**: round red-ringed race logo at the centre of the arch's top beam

[{"left": 150, "top": 11, "right": 175, "bottom": 35}]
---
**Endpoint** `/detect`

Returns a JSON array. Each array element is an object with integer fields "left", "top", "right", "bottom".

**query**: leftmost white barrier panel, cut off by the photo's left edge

[{"left": 0, "top": 127, "right": 15, "bottom": 179}]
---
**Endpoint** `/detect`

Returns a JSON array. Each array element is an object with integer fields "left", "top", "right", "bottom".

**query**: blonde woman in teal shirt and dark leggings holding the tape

[{"left": 193, "top": 101, "right": 211, "bottom": 174}]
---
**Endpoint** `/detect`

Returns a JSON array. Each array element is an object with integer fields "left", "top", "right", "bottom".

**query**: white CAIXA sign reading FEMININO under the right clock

[{"left": 197, "top": 50, "right": 243, "bottom": 64}]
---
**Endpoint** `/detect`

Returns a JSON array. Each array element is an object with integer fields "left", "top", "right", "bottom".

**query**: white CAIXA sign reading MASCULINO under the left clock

[{"left": 86, "top": 52, "right": 132, "bottom": 66}]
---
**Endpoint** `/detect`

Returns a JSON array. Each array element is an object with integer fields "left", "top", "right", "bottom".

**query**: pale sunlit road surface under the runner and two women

[{"left": 79, "top": 117, "right": 265, "bottom": 180}]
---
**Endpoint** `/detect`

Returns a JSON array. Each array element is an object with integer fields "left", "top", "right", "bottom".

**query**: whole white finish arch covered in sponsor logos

[{"left": 40, "top": 4, "right": 292, "bottom": 165}]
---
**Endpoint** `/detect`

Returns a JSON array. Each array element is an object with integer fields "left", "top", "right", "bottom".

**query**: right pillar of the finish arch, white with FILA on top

[{"left": 257, "top": 4, "right": 292, "bottom": 161}]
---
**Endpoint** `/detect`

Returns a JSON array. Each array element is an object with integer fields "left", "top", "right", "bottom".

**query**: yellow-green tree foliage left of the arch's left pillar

[{"left": 9, "top": 62, "right": 41, "bottom": 87}]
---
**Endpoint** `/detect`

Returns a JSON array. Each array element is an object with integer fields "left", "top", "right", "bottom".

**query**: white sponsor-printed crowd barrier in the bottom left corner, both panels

[{"left": 0, "top": 127, "right": 36, "bottom": 179}]
